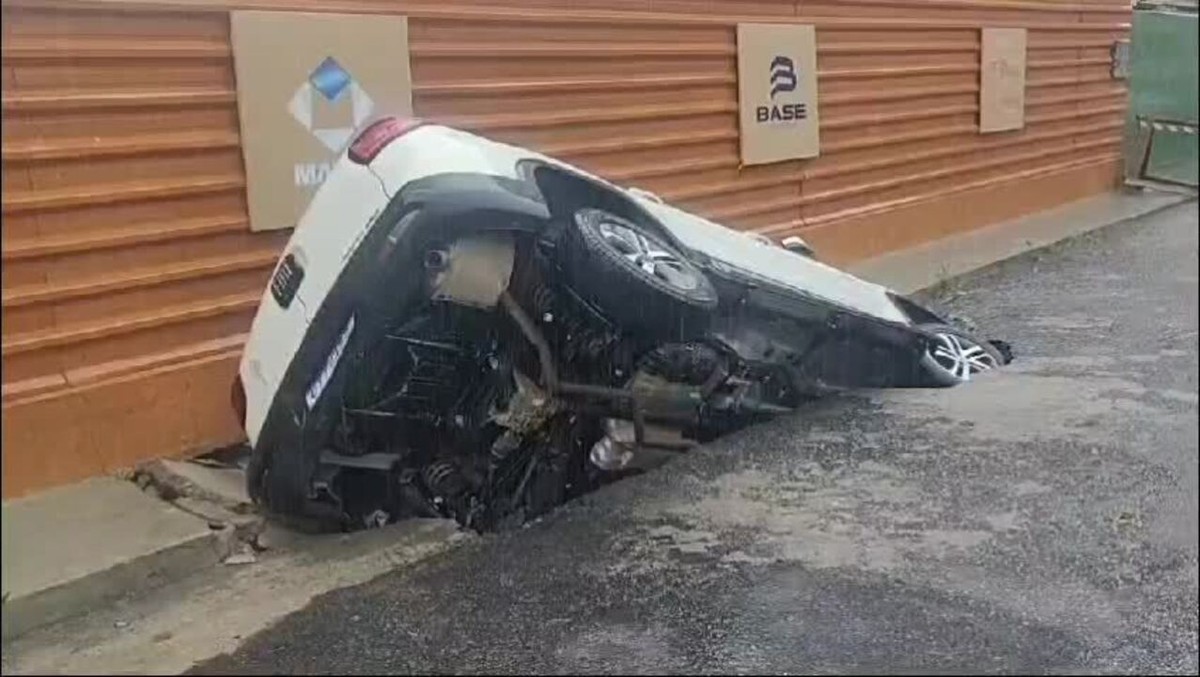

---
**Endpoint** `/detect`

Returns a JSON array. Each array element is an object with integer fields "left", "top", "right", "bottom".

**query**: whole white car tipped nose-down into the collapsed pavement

[{"left": 226, "top": 118, "right": 1010, "bottom": 529}]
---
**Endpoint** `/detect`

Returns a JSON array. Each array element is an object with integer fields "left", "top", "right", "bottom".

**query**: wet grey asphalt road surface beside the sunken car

[{"left": 198, "top": 202, "right": 1198, "bottom": 673}]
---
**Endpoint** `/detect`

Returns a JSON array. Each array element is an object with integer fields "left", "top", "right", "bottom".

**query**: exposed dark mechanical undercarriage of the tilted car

[{"left": 255, "top": 212, "right": 1012, "bottom": 532}]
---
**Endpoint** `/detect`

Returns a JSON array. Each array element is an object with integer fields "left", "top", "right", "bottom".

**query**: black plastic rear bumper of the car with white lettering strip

[{"left": 247, "top": 174, "right": 548, "bottom": 514}]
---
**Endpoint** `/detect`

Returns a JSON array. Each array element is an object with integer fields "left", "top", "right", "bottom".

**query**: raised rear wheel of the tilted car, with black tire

[{"left": 566, "top": 208, "right": 718, "bottom": 339}]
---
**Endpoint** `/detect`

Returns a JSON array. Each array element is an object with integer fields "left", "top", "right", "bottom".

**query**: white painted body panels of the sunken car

[{"left": 239, "top": 125, "right": 911, "bottom": 445}]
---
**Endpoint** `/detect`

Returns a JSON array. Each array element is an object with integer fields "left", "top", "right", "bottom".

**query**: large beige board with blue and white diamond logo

[{"left": 230, "top": 12, "right": 413, "bottom": 230}]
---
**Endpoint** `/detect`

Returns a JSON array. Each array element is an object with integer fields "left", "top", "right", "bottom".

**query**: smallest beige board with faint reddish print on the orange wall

[{"left": 979, "top": 28, "right": 1026, "bottom": 132}]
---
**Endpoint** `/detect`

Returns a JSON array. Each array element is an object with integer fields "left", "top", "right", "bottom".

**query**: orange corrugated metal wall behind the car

[{"left": 2, "top": 0, "right": 1130, "bottom": 497}]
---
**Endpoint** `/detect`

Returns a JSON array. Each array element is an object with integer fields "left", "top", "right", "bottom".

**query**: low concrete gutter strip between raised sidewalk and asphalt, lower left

[{"left": 2, "top": 519, "right": 468, "bottom": 675}]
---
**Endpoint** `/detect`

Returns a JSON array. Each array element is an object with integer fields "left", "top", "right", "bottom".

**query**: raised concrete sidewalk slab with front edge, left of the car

[{"left": 2, "top": 478, "right": 221, "bottom": 640}]
